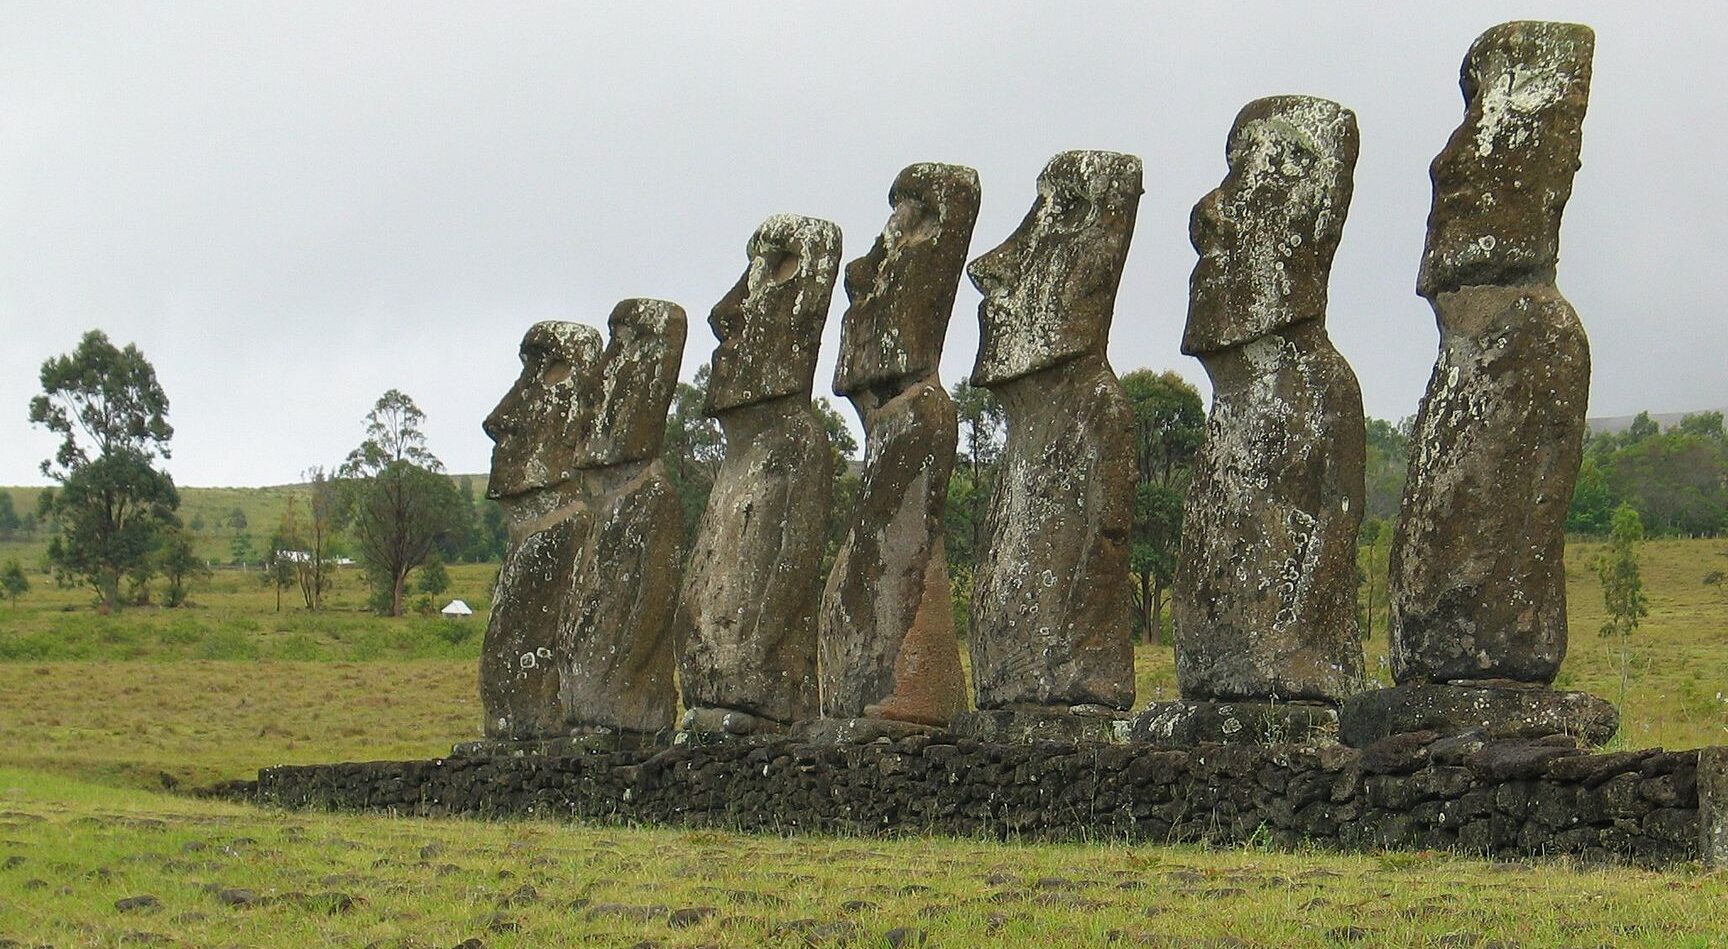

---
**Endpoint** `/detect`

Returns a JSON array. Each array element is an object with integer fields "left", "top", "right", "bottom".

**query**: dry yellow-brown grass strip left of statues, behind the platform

[{"left": 0, "top": 660, "right": 480, "bottom": 788}]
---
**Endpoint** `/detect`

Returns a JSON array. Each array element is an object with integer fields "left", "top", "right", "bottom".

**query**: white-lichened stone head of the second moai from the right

[{"left": 1182, "top": 95, "right": 1358, "bottom": 354}]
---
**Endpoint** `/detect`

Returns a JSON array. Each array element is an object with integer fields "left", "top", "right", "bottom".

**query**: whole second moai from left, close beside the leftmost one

[{"left": 560, "top": 299, "right": 684, "bottom": 733}]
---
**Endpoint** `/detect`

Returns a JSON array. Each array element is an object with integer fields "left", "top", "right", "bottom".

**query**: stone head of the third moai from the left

[{"left": 707, "top": 214, "right": 840, "bottom": 415}]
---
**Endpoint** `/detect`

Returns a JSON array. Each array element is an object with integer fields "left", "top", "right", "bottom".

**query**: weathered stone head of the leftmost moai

[{"left": 484, "top": 322, "right": 600, "bottom": 498}]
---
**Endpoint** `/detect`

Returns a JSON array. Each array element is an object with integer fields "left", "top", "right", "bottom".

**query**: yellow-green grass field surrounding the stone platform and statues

[{"left": 0, "top": 541, "right": 1728, "bottom": 949}]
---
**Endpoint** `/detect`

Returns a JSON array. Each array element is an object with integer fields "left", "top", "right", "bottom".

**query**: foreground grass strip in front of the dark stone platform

[{"left": 0, "top": 769, "right": 1728, "bottom": 947}]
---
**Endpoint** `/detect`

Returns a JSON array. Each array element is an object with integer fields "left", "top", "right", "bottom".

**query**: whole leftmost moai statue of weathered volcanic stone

[{"left": 480, "top": 322, "right": 601, "bottom": 740}]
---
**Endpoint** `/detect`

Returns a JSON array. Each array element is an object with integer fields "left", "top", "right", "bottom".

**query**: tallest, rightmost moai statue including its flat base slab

[{"left": 1343, "top": 22, "right": 1617, "bottom": 743}]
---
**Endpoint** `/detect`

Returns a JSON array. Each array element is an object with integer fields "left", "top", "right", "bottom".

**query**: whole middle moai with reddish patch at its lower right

[{"left": 819, "top": 164, "right": 978, "bottom": 736}]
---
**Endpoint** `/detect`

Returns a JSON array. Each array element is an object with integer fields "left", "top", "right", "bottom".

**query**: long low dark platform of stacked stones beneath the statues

[{"left": 243, "top": 733, "right": 1728, "bottom": 864}]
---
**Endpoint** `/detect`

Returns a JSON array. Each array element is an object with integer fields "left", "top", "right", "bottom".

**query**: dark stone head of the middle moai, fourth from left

[{"left": 835, "top": 162, "right": 978, "bottom": 396}]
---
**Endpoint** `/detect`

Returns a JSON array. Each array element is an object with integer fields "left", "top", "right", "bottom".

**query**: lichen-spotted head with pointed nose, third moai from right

[{"left": 966, "top": 152, "right": 1140, "bottom": 385}]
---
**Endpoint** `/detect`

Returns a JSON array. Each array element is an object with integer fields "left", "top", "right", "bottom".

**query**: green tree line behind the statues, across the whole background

[{"left": 10, "top": 330, "right": 1728, "bottom": 625}]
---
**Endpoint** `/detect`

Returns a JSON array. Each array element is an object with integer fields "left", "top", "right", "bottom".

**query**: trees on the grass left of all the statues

[{"left": 18, "top": 330, "right": 503, "bottom": 615}]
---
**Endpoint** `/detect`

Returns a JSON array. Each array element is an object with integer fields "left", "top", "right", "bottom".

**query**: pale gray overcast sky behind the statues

[{"left": 0, "top": 0, "right": 1728, "bottom": 486}]
